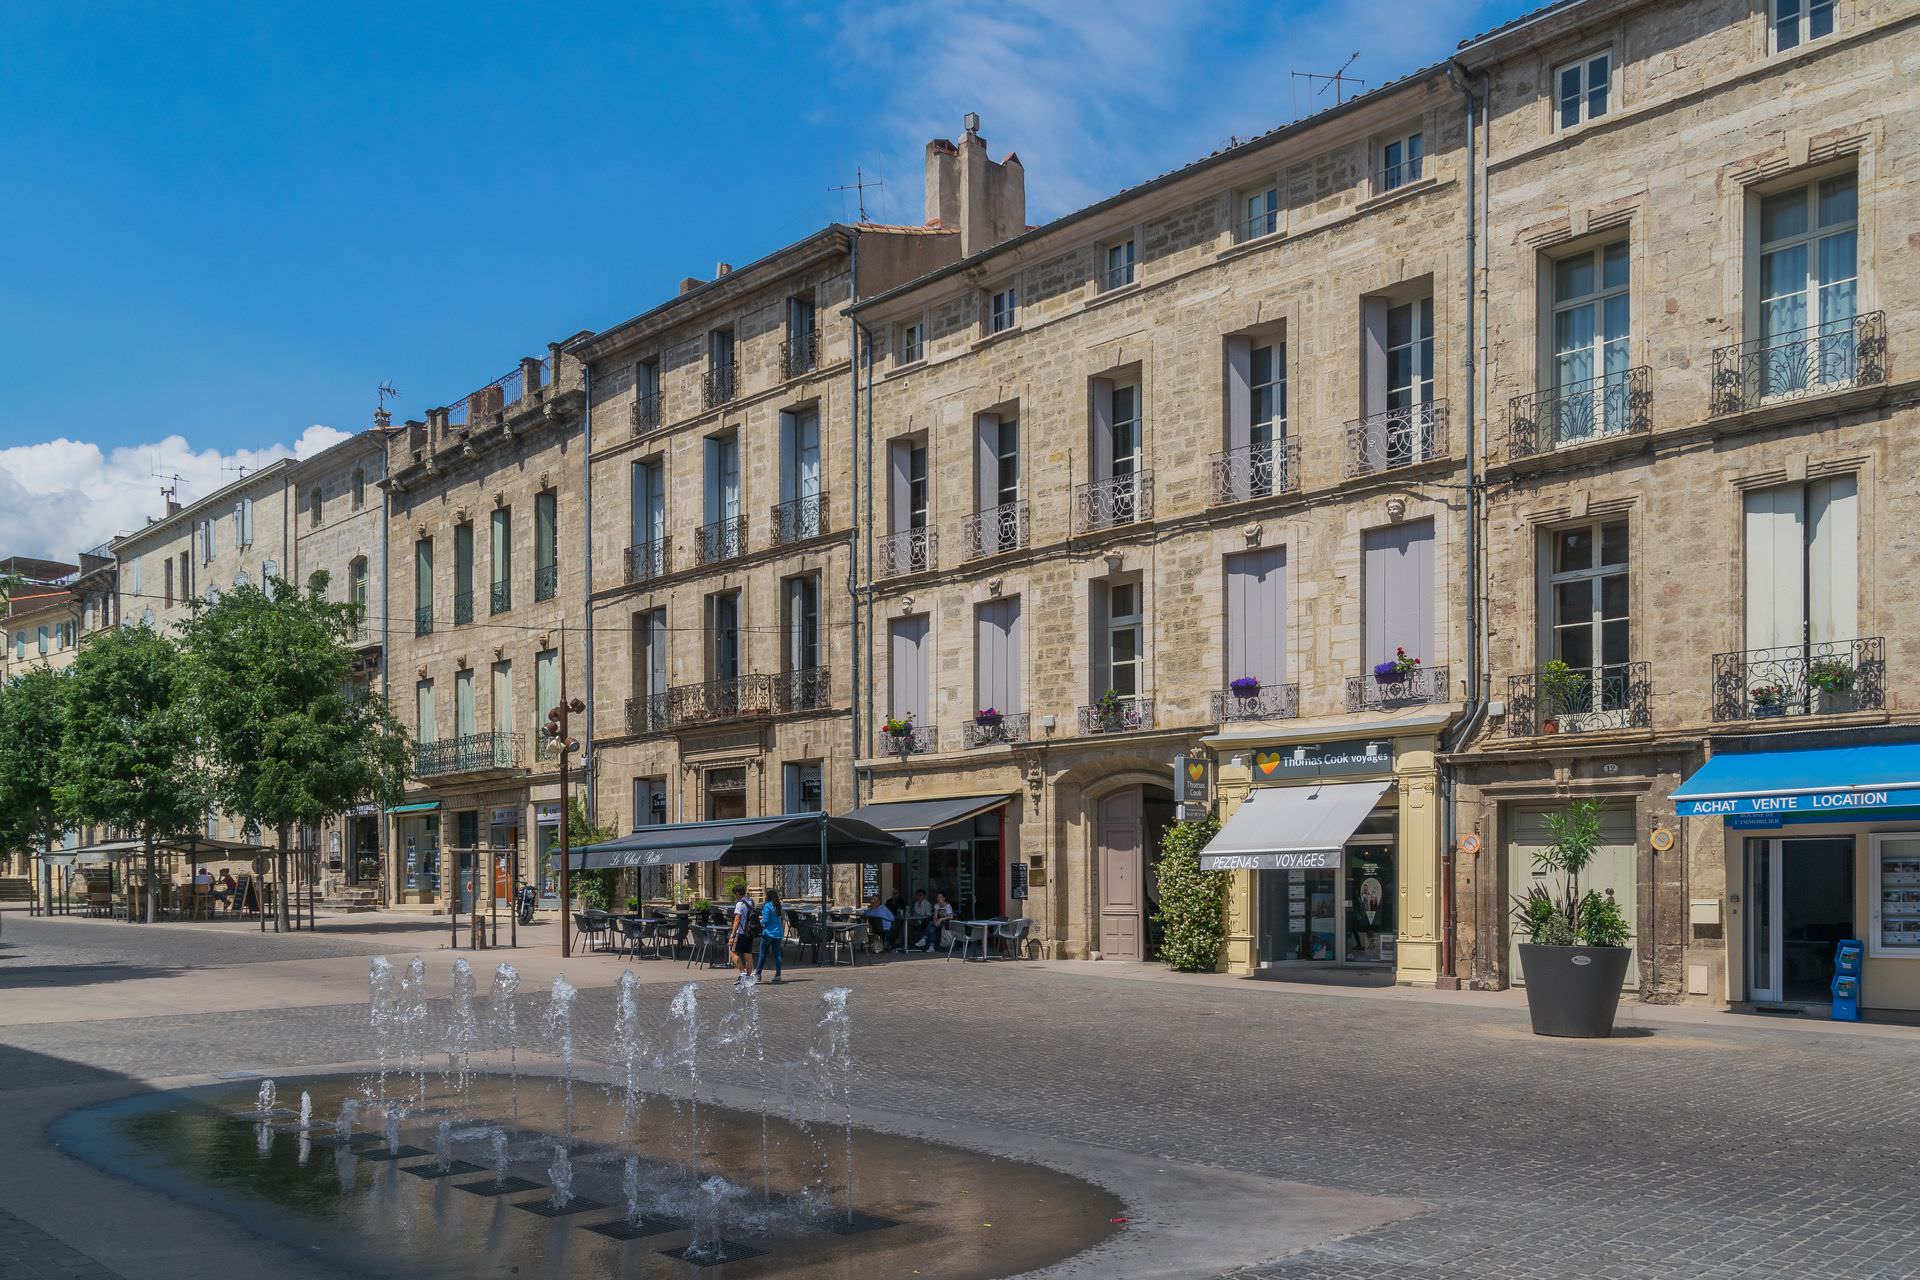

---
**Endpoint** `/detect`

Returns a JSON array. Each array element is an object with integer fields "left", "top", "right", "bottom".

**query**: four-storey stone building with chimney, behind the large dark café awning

[{"left": 578, "top": 132, "right": 1025, "bottom": 894}]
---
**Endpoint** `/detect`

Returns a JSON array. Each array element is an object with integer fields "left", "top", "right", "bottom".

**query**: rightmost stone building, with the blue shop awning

[{"left": 1457, "top": 0, "right": 1920, "bottom": 1009}]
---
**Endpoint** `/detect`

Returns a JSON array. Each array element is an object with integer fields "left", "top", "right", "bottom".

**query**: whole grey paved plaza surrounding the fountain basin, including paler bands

[{"left": 0, "top": 913, "right": 1920, "bottom": 1280}]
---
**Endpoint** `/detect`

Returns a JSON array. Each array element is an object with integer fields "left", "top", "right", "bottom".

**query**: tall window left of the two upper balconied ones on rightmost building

[{"left": 1549, "top": 240, "right": 1632, "bottom": 445}]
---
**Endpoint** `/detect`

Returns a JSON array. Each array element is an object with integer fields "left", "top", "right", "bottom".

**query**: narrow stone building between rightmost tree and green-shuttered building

[{"left": 288, "top": 427, "right": 390, "bottom": 904}]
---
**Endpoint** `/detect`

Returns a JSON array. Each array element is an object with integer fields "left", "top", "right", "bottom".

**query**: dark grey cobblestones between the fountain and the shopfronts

[{"left": 0, "top": 931, "right": 1920, "bottom": 1280}]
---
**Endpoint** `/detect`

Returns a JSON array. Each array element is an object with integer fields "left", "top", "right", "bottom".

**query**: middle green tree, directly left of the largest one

[{"left": 54, "top": 628, "right": 205, "bottom": 919}]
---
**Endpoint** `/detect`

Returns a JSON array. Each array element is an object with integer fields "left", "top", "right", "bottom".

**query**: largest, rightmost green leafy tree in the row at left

[{"left": 180, "top": 574, "right": 413, "bottom": 929}]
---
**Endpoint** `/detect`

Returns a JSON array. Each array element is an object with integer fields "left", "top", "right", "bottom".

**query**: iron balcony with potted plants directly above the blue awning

[{"left": 1713, "top": 635, "right": 1887, "bottom": 720}]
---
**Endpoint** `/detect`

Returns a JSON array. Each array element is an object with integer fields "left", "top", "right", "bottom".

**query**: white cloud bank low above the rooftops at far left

[{"left": 0, "top": 422, "right": 348, "bottom": 560}]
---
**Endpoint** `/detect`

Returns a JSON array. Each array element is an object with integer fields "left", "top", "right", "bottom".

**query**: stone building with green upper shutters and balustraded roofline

[{"left": 384, "top": 336, "right": 589, "bottom": 910}]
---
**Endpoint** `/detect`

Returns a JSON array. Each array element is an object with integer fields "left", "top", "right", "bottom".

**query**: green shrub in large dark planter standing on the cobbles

[{"left": 1513, "top": 800, "right": 1632, "bottom": 1038}]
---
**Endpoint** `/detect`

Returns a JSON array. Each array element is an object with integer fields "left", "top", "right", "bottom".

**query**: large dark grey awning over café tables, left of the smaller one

[{"left": 568, "top": 814, "right": 904, "bottom": 871}]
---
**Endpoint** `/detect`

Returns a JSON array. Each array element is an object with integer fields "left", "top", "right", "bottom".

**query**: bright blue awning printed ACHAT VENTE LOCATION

[{"left": 1674, "top": 743, "right": 1920, "bottom": 819}]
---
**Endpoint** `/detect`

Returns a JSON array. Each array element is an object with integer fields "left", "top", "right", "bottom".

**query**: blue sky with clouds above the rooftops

[{"left": 0, "top": 0, "right": 1532, "bottom": 553}]
